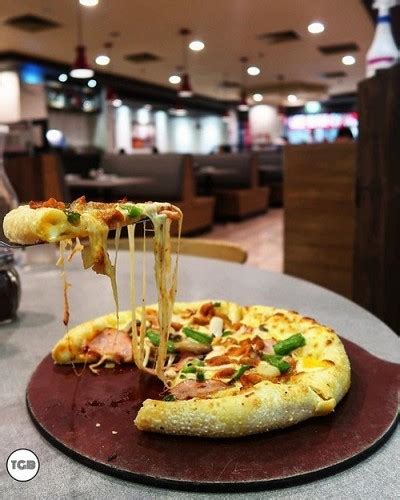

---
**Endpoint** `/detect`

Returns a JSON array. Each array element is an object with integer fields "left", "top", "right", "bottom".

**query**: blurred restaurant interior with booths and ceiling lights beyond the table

[{"left": 0, "top": 0, "right": 400, "bottom": 331}]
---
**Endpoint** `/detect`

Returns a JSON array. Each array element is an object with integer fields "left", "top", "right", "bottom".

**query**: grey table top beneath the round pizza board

[{"left": 0, "top": 252, "right": 400, "bottom": 499}]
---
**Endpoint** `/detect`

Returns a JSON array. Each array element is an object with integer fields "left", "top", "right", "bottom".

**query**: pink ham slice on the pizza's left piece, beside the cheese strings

[{"left": 87, "top": 328, "right": 133, "bottom": 363}]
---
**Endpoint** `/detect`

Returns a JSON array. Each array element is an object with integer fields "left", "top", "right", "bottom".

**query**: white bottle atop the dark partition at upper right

[{"left": 367, "top": 0, "right": 399, "bottom": 78}]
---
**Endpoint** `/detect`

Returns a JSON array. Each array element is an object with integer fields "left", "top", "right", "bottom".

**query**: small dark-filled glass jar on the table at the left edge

[{"left": 0, "top": 248, "right": 21, "bottom": 324}]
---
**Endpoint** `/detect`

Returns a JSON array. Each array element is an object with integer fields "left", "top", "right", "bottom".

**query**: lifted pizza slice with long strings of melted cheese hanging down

[{"left": 3, "top": 196, "right": 183, "bottom": 379}]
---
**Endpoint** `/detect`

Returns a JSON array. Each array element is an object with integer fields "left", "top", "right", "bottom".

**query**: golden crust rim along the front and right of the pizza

[{"left": 135, "top": 305, "right": 350, "bottom": 437}]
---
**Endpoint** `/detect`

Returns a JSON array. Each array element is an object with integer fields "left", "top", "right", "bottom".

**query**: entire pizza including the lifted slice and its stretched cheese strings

[{"left": 3, "top": 198, "right": 350, "bottom": 437}]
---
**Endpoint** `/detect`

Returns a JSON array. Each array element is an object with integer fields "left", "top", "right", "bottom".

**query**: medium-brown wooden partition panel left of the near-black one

[{"left": 284, "top": 143, "right": 356, "bottom": 298}]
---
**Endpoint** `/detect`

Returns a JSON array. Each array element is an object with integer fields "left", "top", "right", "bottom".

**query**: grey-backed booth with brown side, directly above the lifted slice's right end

[{"left": 100, "top": 154, "right": 215, "bottom": 234}]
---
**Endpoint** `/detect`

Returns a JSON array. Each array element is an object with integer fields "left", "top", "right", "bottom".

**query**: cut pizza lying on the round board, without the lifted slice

[{"left": 52, "top": 301, "right": 350, "bottom": 437}]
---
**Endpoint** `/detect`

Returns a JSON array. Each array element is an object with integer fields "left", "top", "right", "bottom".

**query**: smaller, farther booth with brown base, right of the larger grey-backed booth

[{"left": 194, "top": 153, "right": 269, "bottom": 219}]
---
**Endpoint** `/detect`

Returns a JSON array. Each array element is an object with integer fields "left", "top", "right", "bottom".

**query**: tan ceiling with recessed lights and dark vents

[{"left": 0, "top": 0, "right": 373, "bottom": 99}]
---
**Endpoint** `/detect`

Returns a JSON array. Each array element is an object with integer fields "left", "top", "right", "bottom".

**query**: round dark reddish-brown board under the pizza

[{"left": 27, "top": 341, "right": 400, "bottom": 491}]
